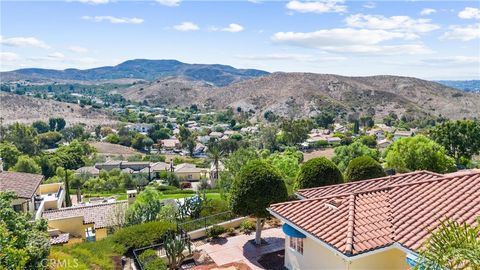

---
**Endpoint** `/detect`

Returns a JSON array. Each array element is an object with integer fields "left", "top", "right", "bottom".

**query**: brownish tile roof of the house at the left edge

[{"left": 0, "top": 171, "right": 43, "bottom": 199}]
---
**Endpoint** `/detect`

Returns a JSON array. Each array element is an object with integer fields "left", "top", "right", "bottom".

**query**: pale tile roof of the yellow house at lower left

[{"left": 43, "top": 201, "right": 127, "bottom": 229}]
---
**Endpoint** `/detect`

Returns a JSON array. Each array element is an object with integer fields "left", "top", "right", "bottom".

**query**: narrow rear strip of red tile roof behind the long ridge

[{"left": 297, "top": 171, "right": 443, "bottom": 199}]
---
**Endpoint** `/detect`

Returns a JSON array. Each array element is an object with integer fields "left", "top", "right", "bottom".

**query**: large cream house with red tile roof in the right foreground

[{"left": 268, "top": 171, "right": 480, "bottom": 270}]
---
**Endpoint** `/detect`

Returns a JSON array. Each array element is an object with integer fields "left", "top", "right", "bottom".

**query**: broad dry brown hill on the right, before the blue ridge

[{"left": 121, "top": 72, "right": 480, "bottom": 119}]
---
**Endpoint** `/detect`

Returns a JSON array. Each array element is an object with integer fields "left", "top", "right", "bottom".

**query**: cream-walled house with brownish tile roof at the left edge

[{"left": 0, "top": 171, "right": 65, "bottom": 219}]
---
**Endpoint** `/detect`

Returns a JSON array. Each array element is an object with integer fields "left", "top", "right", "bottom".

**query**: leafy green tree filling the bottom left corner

[{"left": 0, "top": 192, "right": 50, "bottom": 270}]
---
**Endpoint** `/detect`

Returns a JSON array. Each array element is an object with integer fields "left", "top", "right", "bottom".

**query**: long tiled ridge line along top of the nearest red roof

[{"left": 271, "top": 172, "right": 480, "bottom": 206}]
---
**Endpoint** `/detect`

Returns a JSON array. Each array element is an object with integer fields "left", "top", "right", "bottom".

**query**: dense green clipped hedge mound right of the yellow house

[{"left": 111, "top": 221, "right": 176, "bottom": 250}]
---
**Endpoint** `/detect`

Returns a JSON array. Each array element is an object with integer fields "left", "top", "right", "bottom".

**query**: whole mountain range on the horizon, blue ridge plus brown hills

[{"left": 0, "top": 59, "right": 480, "bottom": 119}]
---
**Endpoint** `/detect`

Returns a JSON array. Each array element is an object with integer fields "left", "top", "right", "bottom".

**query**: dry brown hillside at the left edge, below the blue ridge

[{"left": 0, "top": 92, "right": 118, "bottom": 127}]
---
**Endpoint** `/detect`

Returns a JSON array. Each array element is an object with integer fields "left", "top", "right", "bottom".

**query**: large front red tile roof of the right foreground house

[{"left": 270, "top": 172, "right": 480, "bottom": 256}]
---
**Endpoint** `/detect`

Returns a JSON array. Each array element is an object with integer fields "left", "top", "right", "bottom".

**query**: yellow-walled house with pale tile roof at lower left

[{"left": 43, "top": 201, "right": 128, "bottom": 245}]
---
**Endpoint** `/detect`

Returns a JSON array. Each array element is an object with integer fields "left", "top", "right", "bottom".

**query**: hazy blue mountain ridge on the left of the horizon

[{"left": 1, "top": 59, "right": 269, "bottom": 86}]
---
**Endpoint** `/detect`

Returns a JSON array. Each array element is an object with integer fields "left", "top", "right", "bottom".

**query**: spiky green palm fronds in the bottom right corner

[{"left": 416, "top": 217, "right": 480, "bottom": 270}]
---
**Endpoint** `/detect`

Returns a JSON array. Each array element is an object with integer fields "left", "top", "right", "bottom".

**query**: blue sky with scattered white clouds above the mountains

[{"left": 0, "top": 0, "right": 480, "bottom": 79}]
